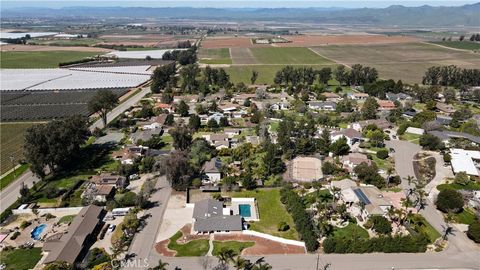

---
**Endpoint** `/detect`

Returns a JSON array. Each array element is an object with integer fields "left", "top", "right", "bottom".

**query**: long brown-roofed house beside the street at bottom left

[{"left": 42, "top": 205, "right": 105, "bottom": 265}]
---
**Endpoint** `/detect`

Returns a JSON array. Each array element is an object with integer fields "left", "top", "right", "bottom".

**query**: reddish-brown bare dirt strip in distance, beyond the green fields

[{"left": 273, "top": 35, "right": 418, "bottom": 47}]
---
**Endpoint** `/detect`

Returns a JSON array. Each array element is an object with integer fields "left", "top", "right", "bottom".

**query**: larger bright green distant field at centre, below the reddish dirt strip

[{"left": 250, "top": 47, "right": 334, "bottom": 65}]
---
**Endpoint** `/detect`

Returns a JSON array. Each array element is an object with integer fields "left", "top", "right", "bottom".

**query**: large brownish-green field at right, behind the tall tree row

[{"left": 313, "top": 43, "right": 480, "bottom": 83}]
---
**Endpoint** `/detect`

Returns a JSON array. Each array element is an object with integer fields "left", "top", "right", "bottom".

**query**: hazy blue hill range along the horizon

[{"left": 1, "top": 3, "right": 480, "bottom": 27}]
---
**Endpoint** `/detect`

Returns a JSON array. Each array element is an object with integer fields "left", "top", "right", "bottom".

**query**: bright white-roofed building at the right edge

[{"left": 450, "top": 148, "right": 480, "bottom": 176}]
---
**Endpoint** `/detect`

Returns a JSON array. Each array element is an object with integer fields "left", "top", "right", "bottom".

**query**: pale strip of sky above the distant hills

[{"left": 1, "top": 0, "right": 480, "bottom": 9}]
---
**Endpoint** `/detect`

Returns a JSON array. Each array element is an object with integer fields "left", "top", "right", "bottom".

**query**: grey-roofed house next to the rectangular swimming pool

[{"left": 192, "top": 199, "right": 243, "bottom": 233}]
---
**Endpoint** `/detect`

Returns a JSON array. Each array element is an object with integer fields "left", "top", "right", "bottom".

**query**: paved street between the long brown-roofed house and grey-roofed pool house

[{"left": 124, "top": 176, "right": 172, "bottom": 269}]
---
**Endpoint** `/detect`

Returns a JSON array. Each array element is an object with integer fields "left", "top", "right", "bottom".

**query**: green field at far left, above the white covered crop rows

[{"left": 0, "top": 51, "right": 98, "bottom": 68}]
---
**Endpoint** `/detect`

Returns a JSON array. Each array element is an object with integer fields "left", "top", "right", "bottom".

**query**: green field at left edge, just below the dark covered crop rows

[{"left": 0, "top": 123, "right": 38, "bottom": 174}]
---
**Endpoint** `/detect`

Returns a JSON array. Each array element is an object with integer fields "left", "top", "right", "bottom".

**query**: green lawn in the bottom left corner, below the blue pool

[{"left": 0, "top": 248, "right": 42, "bottom": 270}]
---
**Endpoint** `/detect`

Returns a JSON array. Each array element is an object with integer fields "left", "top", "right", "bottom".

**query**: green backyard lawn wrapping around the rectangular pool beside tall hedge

[{"left": 225, "top": 188, "right": 299, "bottom": 240}]
